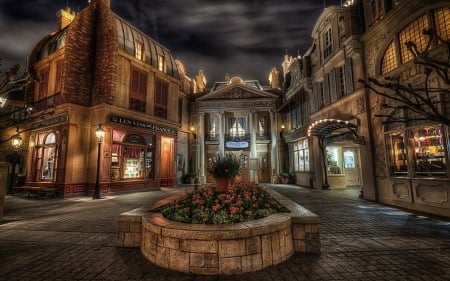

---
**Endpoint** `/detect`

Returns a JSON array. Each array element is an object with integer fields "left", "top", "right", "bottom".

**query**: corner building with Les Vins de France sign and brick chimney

[{"left": 13, "top": 0, "right": 193, "bottom": 196}]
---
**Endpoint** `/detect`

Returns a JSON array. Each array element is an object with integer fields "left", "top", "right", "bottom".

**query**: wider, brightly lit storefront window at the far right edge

[{"left": 411, "top": 125, "right": 447, "bottom": 176}]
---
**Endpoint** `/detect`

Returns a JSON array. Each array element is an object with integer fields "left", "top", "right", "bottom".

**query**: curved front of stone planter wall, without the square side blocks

[{"left": 140, "top": 213, "right": 294, "bottom": 275}]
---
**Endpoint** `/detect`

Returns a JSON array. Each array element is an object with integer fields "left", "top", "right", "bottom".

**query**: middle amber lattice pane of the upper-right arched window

[{"left": 399, "top": 15, "right": 429, "bottom": 63}]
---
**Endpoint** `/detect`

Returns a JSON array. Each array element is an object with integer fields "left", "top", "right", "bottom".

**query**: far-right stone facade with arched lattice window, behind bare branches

[{"left": 361, "top": 1, "right": 450, "bottom": 216}]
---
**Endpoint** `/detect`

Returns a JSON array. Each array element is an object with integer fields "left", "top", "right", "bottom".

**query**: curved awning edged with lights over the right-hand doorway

[{"left": 308, "top": 119, "right": 359, "bottom": 139}]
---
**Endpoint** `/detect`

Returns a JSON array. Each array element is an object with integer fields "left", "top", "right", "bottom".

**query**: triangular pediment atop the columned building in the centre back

[{"left": 197, "top": 84, "right": 278, "bottom": 101}]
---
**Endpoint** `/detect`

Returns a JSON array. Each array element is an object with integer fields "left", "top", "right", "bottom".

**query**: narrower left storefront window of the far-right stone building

[{"left": 387, "top": 132, "right": 408, "bottom": 176}]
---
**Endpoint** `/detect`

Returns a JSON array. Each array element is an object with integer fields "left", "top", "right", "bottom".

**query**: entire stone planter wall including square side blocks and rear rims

[{"left": 117, "top": 186, "right": 320, "bottom": 275}]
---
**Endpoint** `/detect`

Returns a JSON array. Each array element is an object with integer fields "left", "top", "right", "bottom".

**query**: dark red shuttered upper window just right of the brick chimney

[{"left": 130, "top": 67, "right": 148, "bottom": 112}]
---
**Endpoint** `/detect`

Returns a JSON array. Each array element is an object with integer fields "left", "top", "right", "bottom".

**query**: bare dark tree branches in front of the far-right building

[{"left": 359, "top": 29, "right": 450, "bottom": 126}]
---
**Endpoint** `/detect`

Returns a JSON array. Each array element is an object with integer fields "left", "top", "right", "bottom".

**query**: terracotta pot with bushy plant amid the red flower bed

[{"left": 208, "top": 154, "right": 240, "bottom": 192}]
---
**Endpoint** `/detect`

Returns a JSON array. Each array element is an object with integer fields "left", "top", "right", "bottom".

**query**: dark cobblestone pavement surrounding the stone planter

[{"left": 0, "top": 185, "right": 450, "bottom": 281}]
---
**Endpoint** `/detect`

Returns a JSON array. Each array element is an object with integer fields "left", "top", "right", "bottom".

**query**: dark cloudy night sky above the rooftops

[{"left": 0, "top": 0, "right": 341, "bottom": 84}]
